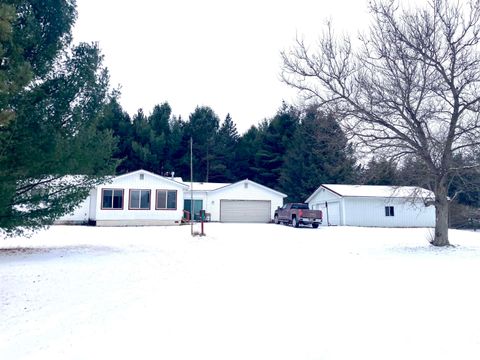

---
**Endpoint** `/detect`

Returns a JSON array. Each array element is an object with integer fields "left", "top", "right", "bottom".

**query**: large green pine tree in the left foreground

[{"left": 0, "top": 0, "right": 115, "bottom": 233}]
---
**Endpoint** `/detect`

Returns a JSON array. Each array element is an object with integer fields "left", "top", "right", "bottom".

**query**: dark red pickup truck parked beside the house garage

[{"left": 273, "top": 203, "right": 322, "bottom": 228}]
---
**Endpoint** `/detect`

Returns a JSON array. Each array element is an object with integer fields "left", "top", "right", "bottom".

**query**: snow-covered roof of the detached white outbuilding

[{"left": 321, "top": 184, "right": 434, "bottom": 198}]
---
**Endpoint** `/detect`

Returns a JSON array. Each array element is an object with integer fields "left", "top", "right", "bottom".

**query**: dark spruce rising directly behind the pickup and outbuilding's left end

[{"left": 279, "top": 107, "right": 356, "bottom": 202}]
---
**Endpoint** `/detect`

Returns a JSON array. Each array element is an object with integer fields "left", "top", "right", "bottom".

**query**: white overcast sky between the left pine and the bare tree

[{"left": 74, "top": 0, "right": 367, "bottom": 133}]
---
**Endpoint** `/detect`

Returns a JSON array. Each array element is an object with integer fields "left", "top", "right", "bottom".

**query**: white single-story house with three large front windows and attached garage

[{"left": 57, "top": 170, "right": 286, "bottom": 226}]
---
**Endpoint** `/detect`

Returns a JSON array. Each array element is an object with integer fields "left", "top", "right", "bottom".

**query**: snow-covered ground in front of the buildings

[{"left": 0, "top": 224, "right": 480, "bottom": 360}]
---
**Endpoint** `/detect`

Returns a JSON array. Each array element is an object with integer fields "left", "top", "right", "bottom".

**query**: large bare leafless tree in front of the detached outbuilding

[{"left": 282, "top": 0, "right": 480, "bottom": 246}]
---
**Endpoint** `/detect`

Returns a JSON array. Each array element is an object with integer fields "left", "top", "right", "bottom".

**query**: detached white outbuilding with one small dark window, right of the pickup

[{"left": 306, "top": 184, "right": 435, "bottom": 227}]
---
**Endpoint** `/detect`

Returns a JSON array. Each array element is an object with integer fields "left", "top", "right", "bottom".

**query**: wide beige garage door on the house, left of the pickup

[{"left": 220, "top": 200, "right": 271, "bottom": 223}]
